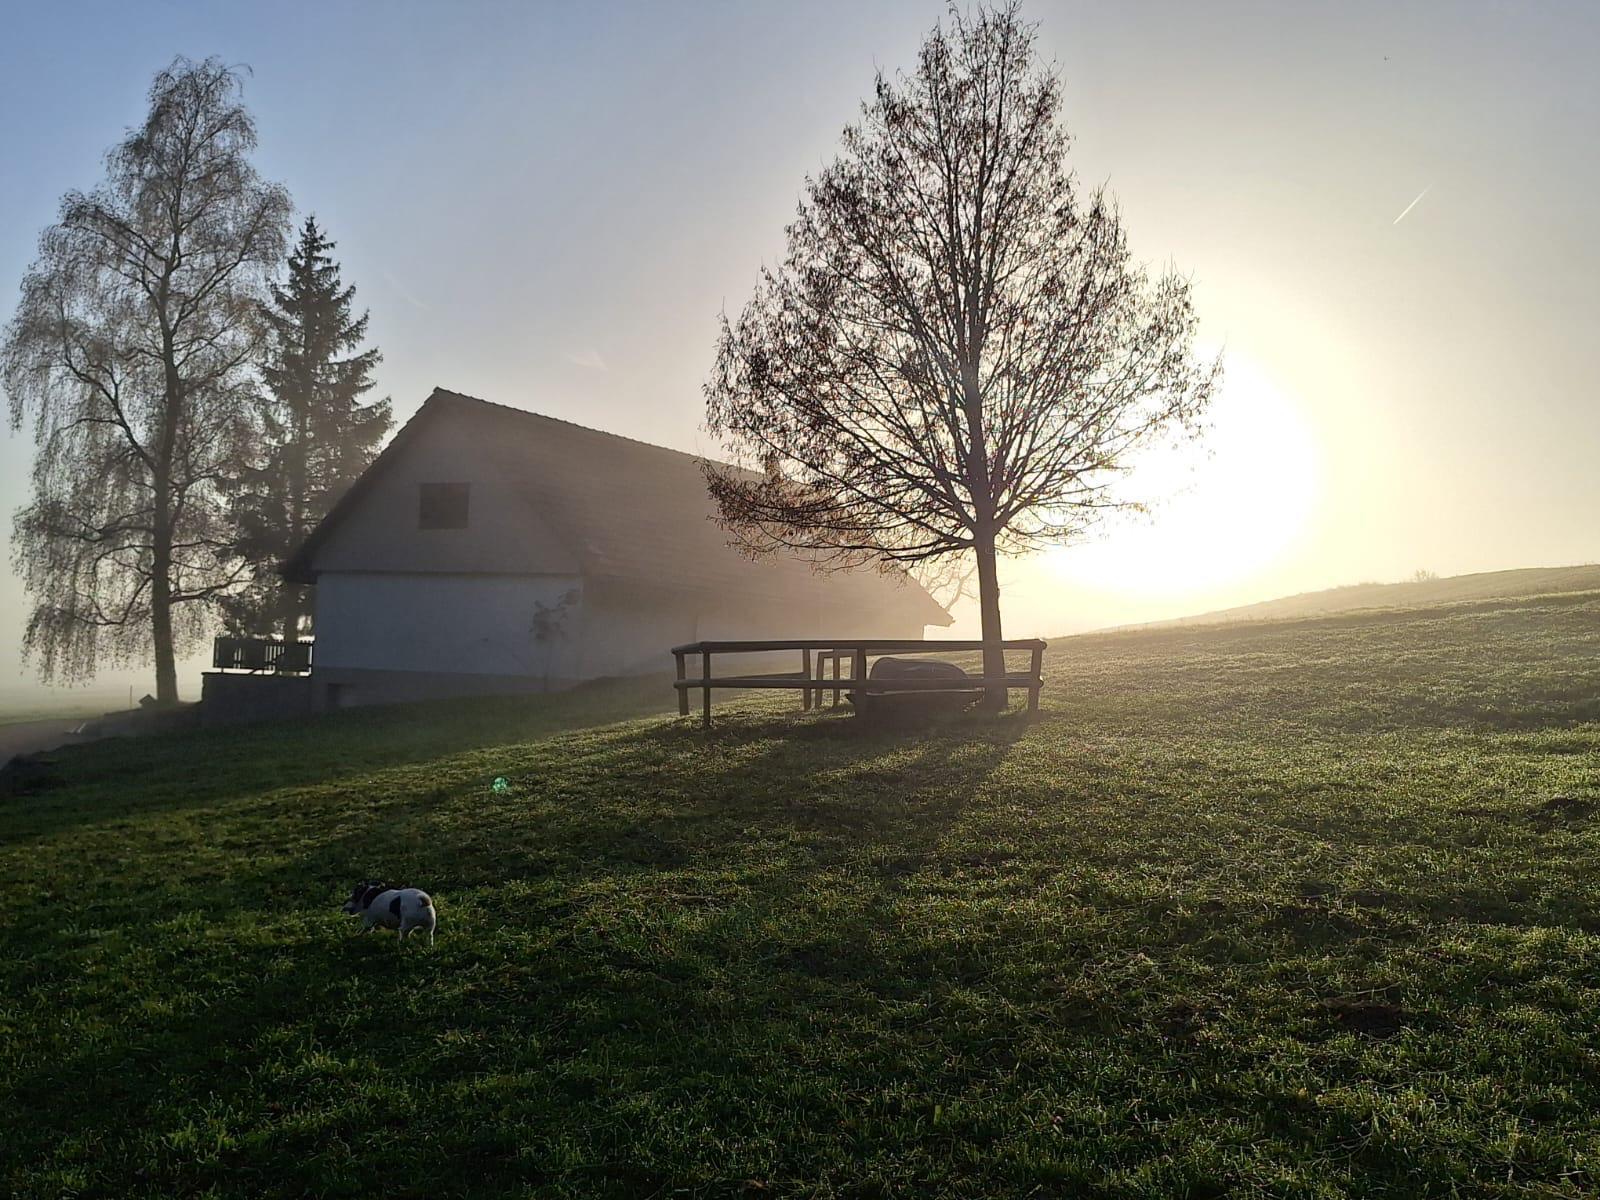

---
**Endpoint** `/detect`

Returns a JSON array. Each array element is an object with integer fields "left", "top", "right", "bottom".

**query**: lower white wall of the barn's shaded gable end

[{"left": 315, "top": 571, "right": 585, "bottom": 678}]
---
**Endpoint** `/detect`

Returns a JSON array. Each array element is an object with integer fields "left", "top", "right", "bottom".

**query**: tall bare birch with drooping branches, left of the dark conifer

[{"left": 0, "top": 58, "right": 290, "bottom": 702}]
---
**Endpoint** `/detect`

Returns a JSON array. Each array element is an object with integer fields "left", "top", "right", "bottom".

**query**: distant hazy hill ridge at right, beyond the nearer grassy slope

[{"left": 1138, "top": 563, "right": 1600, "bottom": 629}]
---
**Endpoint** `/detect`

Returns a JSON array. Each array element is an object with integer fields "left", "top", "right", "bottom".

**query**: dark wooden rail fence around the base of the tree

[{"left": 672, "top": 638, "right": 1048, "bottom": 726}]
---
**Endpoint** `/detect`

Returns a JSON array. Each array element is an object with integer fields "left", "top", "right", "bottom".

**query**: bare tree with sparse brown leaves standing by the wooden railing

[{"left": 706, "top": 5, "right": 1219, "bottom": 704}]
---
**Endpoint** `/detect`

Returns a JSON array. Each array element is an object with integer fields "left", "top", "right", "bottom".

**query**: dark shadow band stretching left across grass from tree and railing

[{"left": 6, "top": 714, "right": 1029, "bottom": 958}]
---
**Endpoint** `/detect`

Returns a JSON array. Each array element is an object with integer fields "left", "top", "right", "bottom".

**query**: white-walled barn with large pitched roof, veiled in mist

[{"left": 270, "top": 389, "right": 950, "bottom": 709}]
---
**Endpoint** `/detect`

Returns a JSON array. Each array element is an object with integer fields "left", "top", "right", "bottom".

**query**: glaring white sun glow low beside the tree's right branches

[{"left": 1043, "top": 354, "right": 1320, "bottom": 597}]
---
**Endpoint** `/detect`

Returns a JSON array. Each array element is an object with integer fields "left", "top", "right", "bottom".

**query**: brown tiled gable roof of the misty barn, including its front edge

[{"left": 283, "top": 389, "right": 950, "bottom": 626}]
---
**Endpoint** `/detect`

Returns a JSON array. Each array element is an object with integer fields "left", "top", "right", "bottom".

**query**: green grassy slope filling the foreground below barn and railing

[{"left": 9, "top": 594, "right": 1600, "bottom": 1197}]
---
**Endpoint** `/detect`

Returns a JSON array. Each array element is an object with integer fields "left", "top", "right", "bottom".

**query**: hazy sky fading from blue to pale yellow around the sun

[{"left": 0, "top": 0, "right": 1600, "bottom": 691}]
